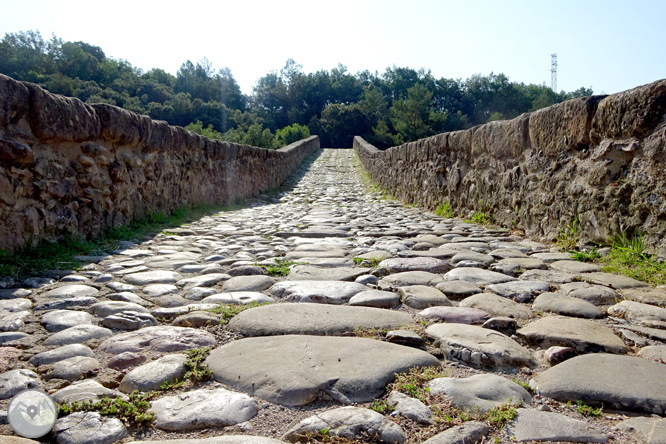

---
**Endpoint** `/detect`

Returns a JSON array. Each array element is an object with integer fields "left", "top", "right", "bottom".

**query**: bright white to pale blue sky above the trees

[{"left": 0, "top": 0, "right": 666, "bottom": 94}]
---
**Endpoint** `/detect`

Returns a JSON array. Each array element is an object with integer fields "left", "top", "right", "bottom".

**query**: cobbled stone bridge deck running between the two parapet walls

[{"left": 0, "top": 149, "right": 666, "bottom": 444}]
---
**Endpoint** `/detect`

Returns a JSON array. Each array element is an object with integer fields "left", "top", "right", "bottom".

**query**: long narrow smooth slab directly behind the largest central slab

[{"left": 229, "top": 303, "right": 414, "bottom": 336}]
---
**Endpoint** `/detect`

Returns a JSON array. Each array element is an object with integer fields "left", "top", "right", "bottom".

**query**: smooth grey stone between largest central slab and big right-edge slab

[{"left": 428, "top": 374, "right": 532, "bottom": 412}]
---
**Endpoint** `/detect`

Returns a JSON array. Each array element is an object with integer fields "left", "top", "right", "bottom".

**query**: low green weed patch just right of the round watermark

[{"left": 58, "top": 390, "right": 158, "bottom": 425}]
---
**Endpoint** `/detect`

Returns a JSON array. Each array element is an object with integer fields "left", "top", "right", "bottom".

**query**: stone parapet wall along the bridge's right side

[{"left": 354, "top": 80, "right": 666, "bottom": 256}]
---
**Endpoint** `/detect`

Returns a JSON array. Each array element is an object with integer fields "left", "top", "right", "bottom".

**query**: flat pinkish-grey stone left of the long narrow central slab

[{"left": 98, "top": 325, "right": 215, "bottom": 354}]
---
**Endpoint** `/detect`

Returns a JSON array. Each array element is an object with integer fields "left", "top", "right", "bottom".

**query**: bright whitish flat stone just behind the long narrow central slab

[{"left": 268, "top": 281, "right": 368, "bottom": 304}]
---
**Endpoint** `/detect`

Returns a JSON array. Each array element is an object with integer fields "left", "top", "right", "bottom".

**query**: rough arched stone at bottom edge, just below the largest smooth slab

[{"left": 282, "top": 407, "right": 407, "bottom": 444}]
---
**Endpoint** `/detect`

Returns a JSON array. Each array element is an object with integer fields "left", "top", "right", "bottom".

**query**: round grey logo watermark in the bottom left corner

[{"left": 7, "top": 389, "right": 58, "bottom": 438}]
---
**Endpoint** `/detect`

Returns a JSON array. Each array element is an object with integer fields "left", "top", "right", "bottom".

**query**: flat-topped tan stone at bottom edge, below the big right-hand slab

[{"left": 506, "top": 409, "right": 609, "bottom": 442}]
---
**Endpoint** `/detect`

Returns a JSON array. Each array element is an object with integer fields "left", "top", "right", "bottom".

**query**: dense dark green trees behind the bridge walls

[{"left": 0, "top": 31, "right": 592, "bottom": 148}]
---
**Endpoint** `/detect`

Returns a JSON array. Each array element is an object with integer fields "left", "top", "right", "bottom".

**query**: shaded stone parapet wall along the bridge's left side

[{"left": 0, "top": 75, "right": 319, "bottom": 251}]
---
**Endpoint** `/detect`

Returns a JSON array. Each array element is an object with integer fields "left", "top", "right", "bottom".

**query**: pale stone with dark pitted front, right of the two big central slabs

[{"left": 426, "top": 324, "right": 536, "bottom": 368}]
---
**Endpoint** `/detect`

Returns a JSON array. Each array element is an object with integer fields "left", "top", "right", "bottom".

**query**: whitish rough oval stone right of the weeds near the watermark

[{"left": 150, "top": 388, "right": 258, "bottom": 431}]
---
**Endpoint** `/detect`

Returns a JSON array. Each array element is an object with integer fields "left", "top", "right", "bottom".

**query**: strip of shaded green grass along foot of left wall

[{"left": 0, "top": 204, "right": 236, "bottom": 279}]
